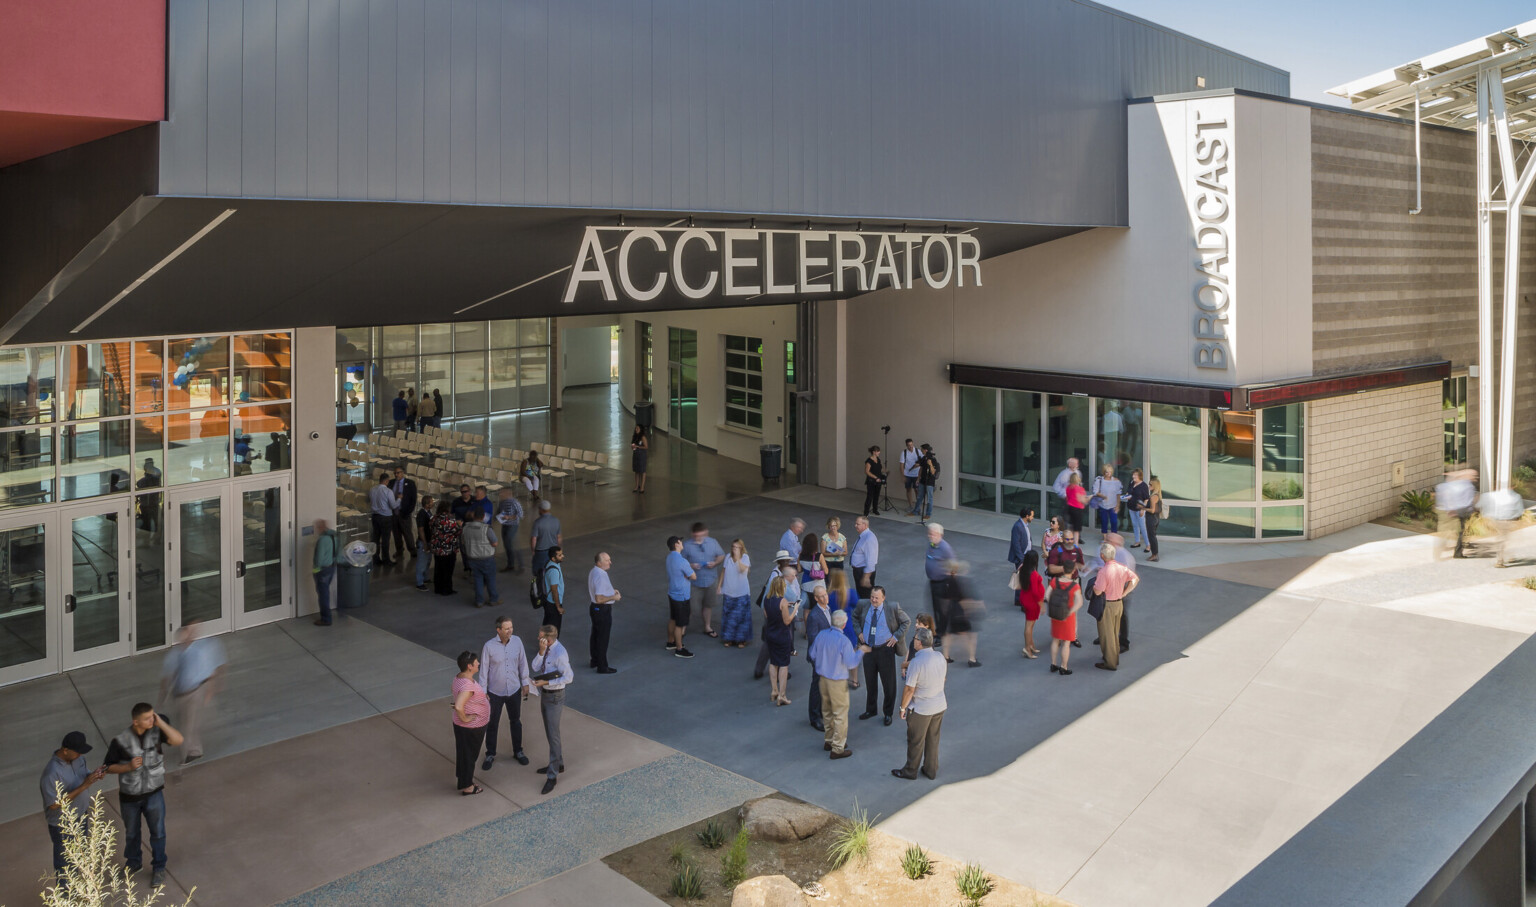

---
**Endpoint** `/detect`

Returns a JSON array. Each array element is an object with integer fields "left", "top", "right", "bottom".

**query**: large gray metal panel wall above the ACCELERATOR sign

[{"left": 160, "top": 0, "right": 1289, "bottom": 224}]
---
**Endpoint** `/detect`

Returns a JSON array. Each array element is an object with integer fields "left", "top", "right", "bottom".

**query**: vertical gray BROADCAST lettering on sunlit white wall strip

[{"left": 1184, "top": 98, "right": 1238, "bottom": 372}]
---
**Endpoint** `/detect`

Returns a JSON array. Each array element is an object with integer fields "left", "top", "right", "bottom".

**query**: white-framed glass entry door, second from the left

[{"left": 58, "top": 497, "right": 134, "bottom": 670}]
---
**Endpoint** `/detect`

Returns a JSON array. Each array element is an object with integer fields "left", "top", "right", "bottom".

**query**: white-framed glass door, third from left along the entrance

[{"left": 166, "top": 486, "right": 233, "bottom": 633}]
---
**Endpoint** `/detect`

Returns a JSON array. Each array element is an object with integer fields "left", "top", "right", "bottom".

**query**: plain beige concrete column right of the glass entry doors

[{"left": 293, "top": 327, "right": 336, "bottom": 615}]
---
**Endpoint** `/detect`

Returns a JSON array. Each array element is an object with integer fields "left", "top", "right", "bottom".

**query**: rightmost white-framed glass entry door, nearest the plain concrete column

[{"left": 230, "top": 473, "right": 293, "bottom": 629}]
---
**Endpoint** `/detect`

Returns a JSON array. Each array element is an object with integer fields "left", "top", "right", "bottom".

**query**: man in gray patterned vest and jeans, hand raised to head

[{"left": 103, "top": 703, "right": 183, "bottom": 887}]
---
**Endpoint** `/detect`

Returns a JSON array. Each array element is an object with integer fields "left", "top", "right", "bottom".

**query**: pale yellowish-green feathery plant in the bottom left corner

[{"left": 43, "top": 784, "right": 197, "bottom": 907}]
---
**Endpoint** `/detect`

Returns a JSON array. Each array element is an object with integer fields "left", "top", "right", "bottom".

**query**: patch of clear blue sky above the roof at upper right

[{"left": 1100, "top": 0, "right": 1536, "bottom": 103}]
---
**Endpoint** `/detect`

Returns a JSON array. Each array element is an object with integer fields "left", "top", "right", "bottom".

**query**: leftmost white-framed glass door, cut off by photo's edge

[{"left": 0, "top": 515, "right": 58, "bottom": 684}]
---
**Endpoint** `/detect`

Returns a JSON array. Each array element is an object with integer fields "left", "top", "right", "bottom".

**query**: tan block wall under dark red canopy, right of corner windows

[{"left": 1307, "top": 381, "right": 1444, "bottom": 538}]
